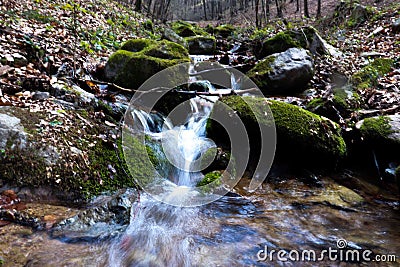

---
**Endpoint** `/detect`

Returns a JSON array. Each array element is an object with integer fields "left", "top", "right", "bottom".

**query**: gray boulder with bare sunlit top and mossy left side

[{"left": 248, "top": 48, "right": 314, "bottom": 95}]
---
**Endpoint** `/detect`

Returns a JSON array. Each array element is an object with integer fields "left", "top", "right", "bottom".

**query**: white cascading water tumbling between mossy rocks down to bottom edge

[{"left": 108, "top": 87, "right": 219, "bottom": 266}]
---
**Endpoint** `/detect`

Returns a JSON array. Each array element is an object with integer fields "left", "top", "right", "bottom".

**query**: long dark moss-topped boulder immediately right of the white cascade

[{"left": 207, "top": 96, "right": 346, "bottom": 167}]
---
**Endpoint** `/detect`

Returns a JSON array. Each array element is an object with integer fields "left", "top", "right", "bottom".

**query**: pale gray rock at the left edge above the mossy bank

[{"left": 0, "top": 113, "right": 27, "bottom": 149}]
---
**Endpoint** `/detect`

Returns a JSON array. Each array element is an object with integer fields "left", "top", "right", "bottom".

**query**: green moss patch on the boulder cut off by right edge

[{"left": 360, "top": 116, "right": 392, "bottom": 143}]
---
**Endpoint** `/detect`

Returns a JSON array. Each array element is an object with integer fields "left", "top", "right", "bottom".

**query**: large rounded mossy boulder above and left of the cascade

[{"left": 105, "top": 39, "right": 190, "bottom": 89}]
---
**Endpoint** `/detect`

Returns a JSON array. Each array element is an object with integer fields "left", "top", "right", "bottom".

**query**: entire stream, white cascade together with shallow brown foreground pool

[{"left": 0, "top": 57, "right": 400, "bottom": 267}]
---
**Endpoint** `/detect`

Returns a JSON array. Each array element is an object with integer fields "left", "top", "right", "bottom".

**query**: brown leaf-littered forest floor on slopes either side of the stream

[{"left": 0, "top": 0, "right": 400, "bottom": 195}]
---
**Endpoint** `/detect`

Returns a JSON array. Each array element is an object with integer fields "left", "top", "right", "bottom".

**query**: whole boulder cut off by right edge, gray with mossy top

[{"left": 356, "top": 114, "right": 400, "bottom": 160}]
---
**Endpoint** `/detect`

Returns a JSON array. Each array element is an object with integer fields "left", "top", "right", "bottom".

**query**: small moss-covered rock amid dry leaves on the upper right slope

[{"left": 351, "top": 58, "right": 394, "bottom": 89}]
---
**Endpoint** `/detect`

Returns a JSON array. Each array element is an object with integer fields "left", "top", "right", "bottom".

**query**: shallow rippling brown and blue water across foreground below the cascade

[{"left": 0, "top": 173, "right": 400, "bottom": 266}]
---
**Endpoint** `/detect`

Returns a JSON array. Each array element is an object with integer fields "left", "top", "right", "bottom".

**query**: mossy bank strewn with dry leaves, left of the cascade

[{"left": 0, "top": 109, "right": 145, "bottom": 199}]
